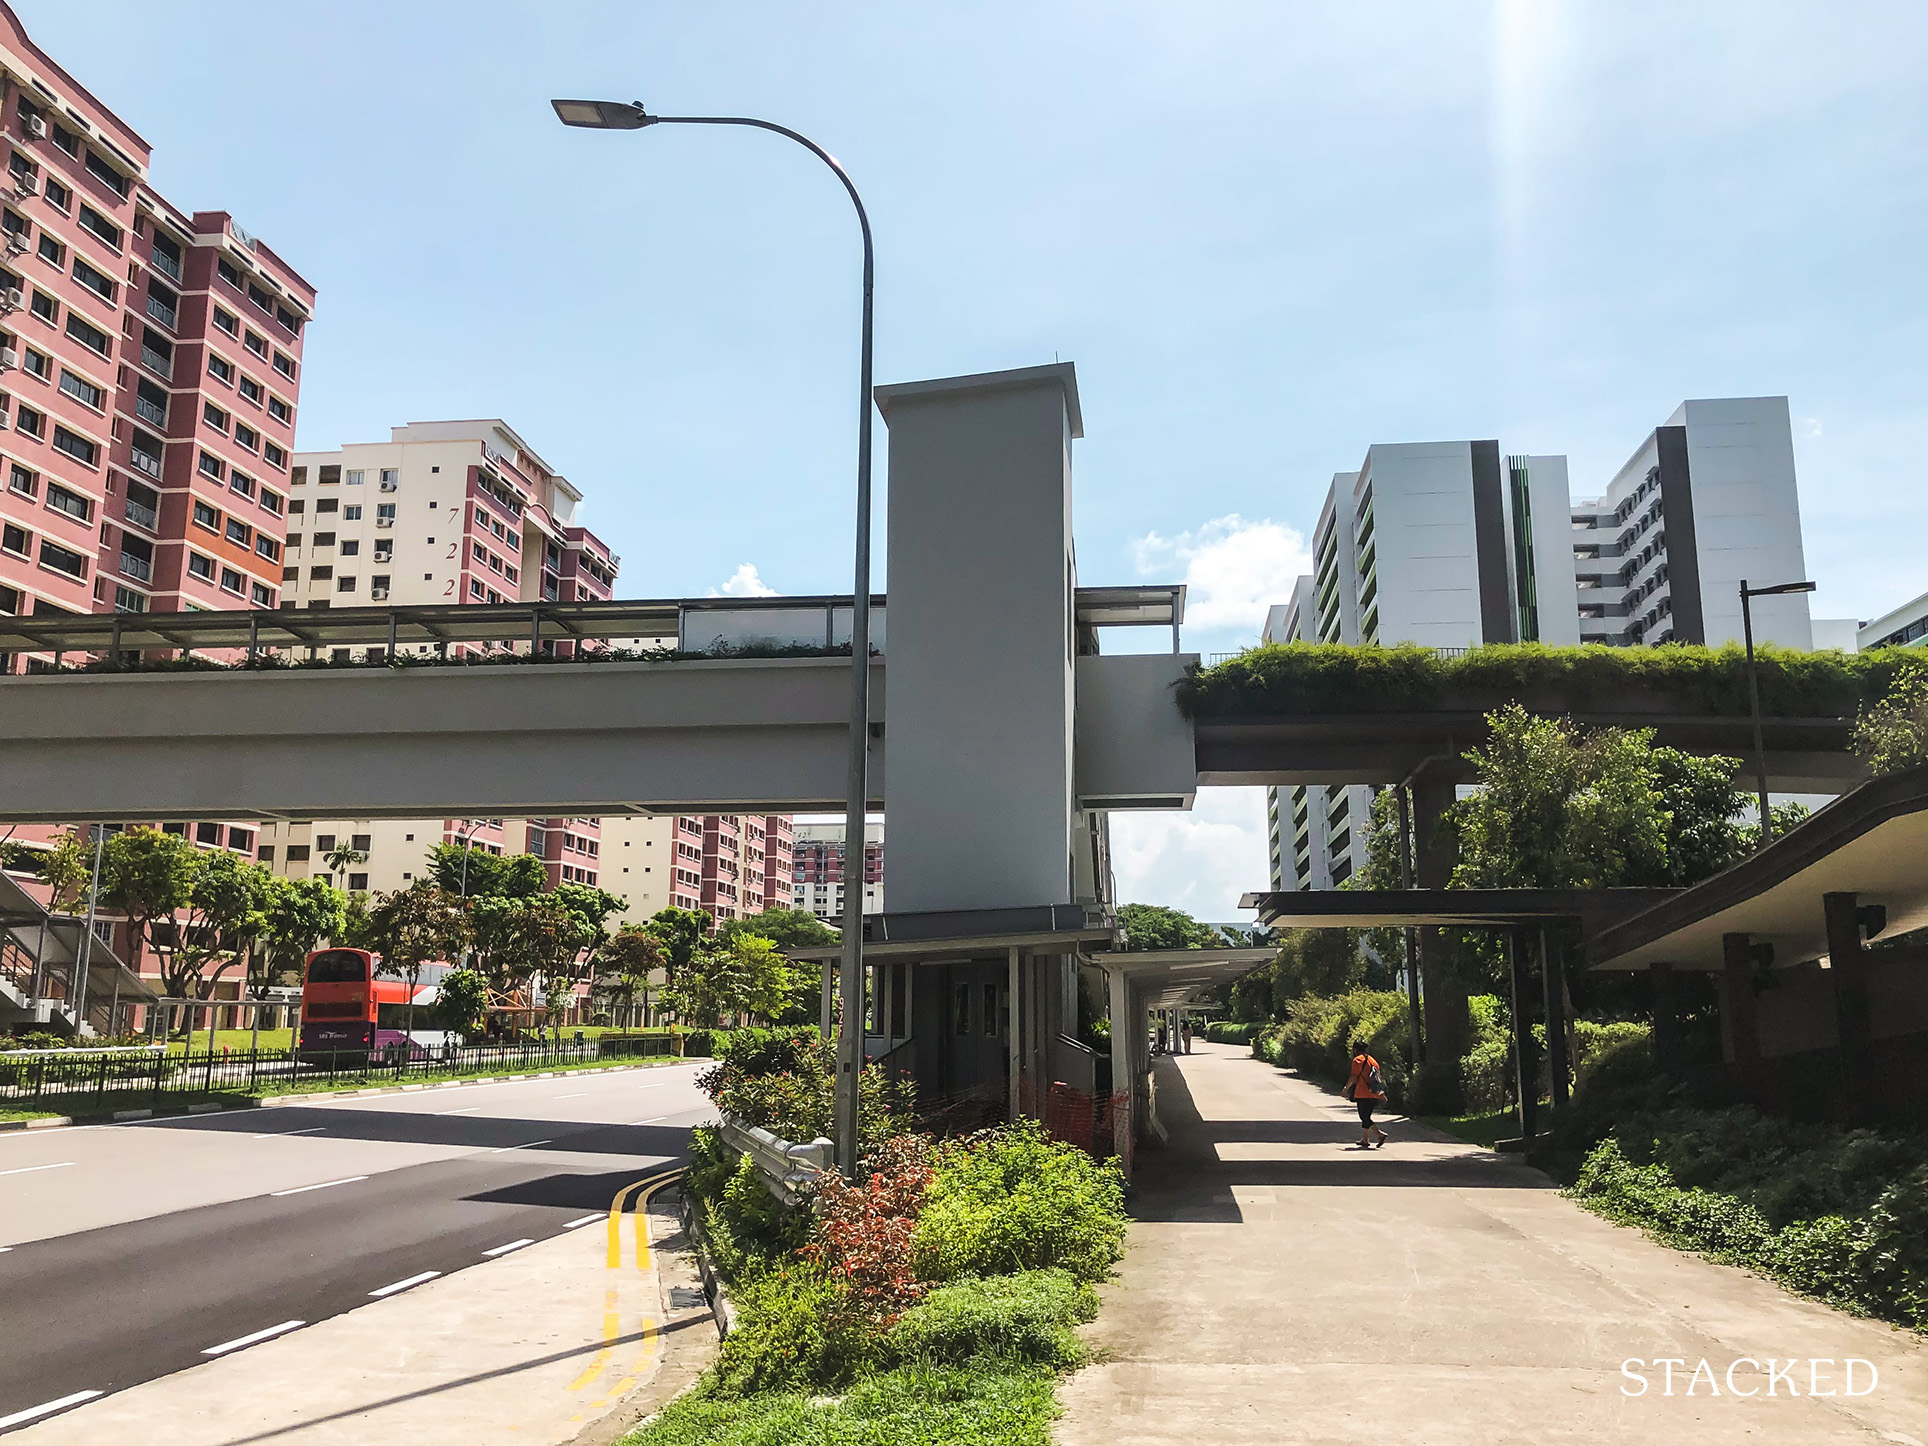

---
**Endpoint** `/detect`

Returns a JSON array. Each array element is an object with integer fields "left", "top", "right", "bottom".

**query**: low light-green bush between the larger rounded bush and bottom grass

[{"left": 881, "top": 1271, "right": 1097, "bottom": 1371}]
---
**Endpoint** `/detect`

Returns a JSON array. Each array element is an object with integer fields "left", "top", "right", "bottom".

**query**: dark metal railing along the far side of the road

[{"left": 0, "top": 1035, "right": 677, "bottom": 1109}]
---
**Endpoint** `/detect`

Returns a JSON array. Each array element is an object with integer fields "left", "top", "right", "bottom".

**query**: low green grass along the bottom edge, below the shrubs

[{"left": 623, "top": 1359, "right": 1058, "bottom": 1446}]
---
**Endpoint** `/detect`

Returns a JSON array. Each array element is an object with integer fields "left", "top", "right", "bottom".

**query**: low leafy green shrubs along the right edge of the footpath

[{"left": 1567, "top": 1138, "right": 1928, "bottom": 1330}]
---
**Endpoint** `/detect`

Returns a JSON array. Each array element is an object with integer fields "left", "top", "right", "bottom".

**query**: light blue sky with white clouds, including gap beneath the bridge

[{"left": 26, "top": 0, "right": 1928, "bottom": 918}]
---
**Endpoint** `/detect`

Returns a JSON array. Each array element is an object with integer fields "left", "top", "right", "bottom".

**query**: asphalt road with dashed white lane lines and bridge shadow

[{"left": 0, "top": 1064, "right": 713, "bottom": 1434}]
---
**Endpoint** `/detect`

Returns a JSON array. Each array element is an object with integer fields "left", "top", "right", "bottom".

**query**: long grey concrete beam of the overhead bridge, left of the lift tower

[{"left": 0, "top": 657, "right": 885, "bottom": 823}]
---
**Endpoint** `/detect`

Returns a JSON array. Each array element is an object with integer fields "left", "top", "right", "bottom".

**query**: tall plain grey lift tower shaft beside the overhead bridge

[{"left": 877, "top": 364, "right": 1082, "bottom": 912}]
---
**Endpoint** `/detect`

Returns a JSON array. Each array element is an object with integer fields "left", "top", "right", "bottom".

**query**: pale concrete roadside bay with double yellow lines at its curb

[{"left": 10, "top": 1190, "right": 717, "bottom": 1446}]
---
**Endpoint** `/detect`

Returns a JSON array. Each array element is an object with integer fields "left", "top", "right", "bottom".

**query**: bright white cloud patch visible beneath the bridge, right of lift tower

[{"left": 1111, "top": 789, "right": 1272, "bottom": 924}]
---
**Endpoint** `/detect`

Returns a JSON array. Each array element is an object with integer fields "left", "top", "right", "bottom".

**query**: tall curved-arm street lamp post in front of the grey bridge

[{"left": 549, "top": 100, "right": 877, "bottom": 1176}]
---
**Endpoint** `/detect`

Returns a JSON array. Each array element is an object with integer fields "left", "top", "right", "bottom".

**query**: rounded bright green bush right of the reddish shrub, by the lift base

[{"left": 910, "top": 1120, "right": 1126, "bottom": 1280}]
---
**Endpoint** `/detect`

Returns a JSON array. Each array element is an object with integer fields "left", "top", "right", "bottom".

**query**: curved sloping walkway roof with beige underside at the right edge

[{"left": 1585, "top": 767, "right": 1928, "bottom": 970}]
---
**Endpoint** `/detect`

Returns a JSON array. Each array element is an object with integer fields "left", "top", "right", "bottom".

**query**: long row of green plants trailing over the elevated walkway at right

[{"left": 1178, "top": 642, "right": 1928, "bottom": 717}]
